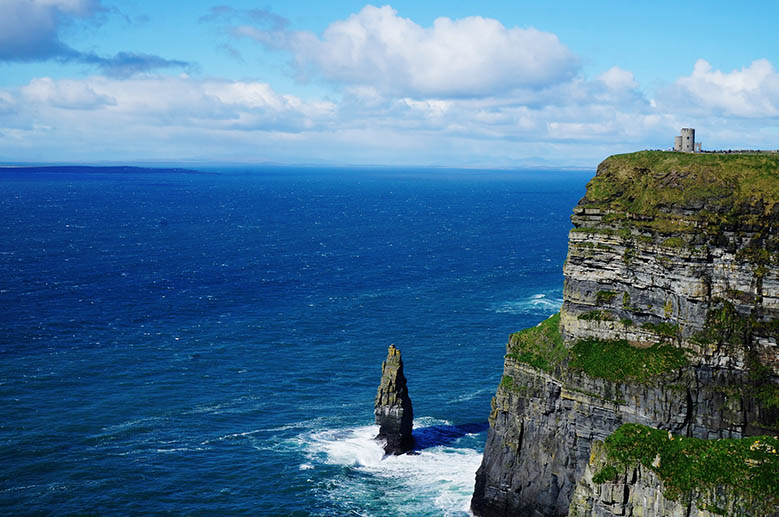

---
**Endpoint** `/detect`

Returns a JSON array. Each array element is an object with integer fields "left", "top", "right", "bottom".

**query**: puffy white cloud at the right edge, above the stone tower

[{"left": 665, "top": 59, "right": 779, "bottom": 118}]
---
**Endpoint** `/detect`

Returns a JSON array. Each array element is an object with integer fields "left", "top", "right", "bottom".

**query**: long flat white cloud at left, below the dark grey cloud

[{"left": 5, "top": 75, "right": 333, "bottom": 131}]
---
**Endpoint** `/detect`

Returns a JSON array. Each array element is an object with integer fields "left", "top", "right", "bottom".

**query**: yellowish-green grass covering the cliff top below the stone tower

[{"left": 583, "top": 151, "right": 779, "bottom": 215}]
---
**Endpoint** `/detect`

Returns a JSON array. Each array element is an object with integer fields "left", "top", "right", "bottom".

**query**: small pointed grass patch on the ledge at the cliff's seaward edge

[{"left": 506, "top": 313, "right": 568, "bottom": 372}]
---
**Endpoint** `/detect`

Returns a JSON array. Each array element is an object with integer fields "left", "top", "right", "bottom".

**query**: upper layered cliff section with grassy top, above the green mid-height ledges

[{"left": 561, "top": 153, "right": 779, "bottom": 374}]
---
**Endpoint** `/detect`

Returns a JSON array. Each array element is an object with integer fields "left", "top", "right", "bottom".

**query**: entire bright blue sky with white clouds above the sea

[{"left": 0, "top": 0, "right": 779, "bottom": 168}]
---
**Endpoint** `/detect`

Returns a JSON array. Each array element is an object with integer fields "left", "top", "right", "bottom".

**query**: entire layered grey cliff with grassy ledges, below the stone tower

[{"left": 472, "top": 151, "right": 779, "bottom": 516}]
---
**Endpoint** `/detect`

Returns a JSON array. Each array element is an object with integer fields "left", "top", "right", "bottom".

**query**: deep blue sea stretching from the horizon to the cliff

[{"left": 0, "top": 168, "right": 592, "bottom": 516}]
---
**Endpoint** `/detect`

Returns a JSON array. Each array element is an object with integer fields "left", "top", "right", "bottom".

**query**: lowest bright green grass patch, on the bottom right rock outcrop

[{"left": 604, "top": 424, "right": 779, "bottom": 508}]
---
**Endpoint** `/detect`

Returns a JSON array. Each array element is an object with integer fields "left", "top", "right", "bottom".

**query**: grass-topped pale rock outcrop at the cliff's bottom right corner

[{"left": 569, "top": 424, "right": 779, "bottom": 517}]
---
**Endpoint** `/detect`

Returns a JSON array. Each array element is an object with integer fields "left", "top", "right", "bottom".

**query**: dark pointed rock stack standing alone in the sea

[{"left": 373, "top": 345, "right": 414, "bottom": 455}]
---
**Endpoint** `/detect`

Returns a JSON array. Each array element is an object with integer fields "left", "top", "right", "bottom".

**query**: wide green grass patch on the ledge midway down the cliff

[{"left": 569, "top": 338, "right": 687, "bottom": 383}]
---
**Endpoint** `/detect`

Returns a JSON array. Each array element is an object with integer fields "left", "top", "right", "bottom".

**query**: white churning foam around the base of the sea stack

[{"left": 301, "top": 418, "right": 481, "bottom": 516}]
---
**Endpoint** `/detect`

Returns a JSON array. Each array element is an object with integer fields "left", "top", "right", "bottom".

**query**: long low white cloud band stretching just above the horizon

[{"left": 0, "top": 52, "right": 670, "bottom": 165}]
